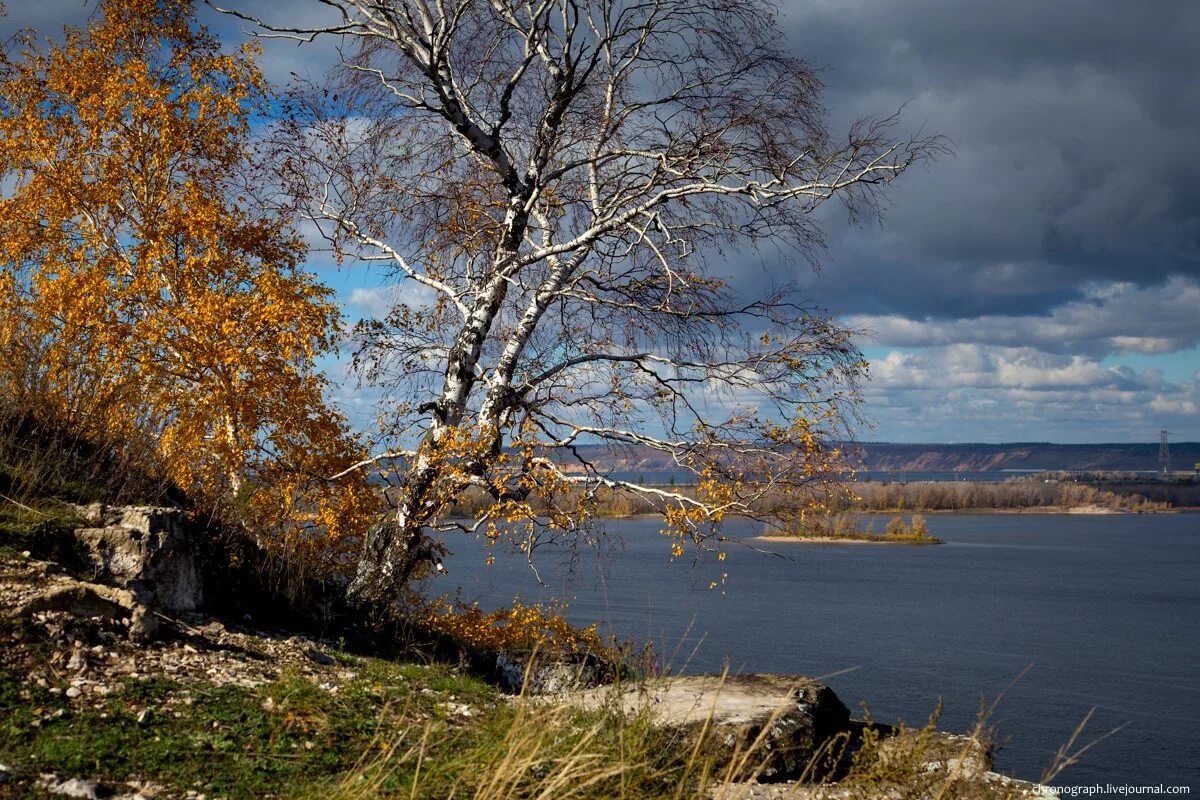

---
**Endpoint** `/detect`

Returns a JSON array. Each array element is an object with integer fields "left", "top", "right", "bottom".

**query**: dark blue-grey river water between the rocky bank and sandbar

[{"left": 439, "top": 515, "right": 1200, "bottom": 788}]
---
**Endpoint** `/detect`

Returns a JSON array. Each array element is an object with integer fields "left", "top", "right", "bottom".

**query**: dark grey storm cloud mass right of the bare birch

[{"left": 768, "top": 0, "right": 1200, "bottom": 317}]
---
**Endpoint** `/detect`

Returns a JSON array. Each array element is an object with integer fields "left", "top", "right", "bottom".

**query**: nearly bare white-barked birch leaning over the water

[{"left": 218, "top": 0, "right": 941, "bottom": 597}]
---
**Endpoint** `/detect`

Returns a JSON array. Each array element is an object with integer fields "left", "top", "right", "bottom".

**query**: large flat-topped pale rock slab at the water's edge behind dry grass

[{"left": 566, "top": 674, "right": 850, "bottom": 781}]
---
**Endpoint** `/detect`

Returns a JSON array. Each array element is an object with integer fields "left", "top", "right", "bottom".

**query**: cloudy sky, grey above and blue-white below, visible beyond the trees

[{"left": 0, "top": 0, "right": 1200, "bottom": 443}]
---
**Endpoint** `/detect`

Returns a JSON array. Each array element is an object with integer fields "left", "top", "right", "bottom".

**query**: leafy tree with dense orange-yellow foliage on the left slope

[{"left": 0, "top": 0, "right": 378, "bottom": 556}]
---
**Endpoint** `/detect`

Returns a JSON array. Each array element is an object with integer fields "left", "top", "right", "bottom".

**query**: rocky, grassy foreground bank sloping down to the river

[{"left": 0, "top": 507, "right": 1048, "bottom": 800}]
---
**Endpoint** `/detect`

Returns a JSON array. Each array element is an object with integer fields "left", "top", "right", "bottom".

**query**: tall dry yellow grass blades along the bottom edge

[{"left": 323, "top": 657, "right": 1060, "bottom": 800}]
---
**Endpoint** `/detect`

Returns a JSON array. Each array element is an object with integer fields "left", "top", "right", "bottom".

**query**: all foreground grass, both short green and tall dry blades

[{"left": 0, "top": 654, "right": 1056, "bottom": 800}]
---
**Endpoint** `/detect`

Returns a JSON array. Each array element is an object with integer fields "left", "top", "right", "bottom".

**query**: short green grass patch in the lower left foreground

[{"left": 0, "top": 661, "right": 499, "bottom": 799}]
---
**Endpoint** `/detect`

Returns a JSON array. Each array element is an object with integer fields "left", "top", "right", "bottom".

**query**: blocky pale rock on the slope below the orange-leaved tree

[{"left": 74, "top": 505, "right": 204, "bottom": 612}]
